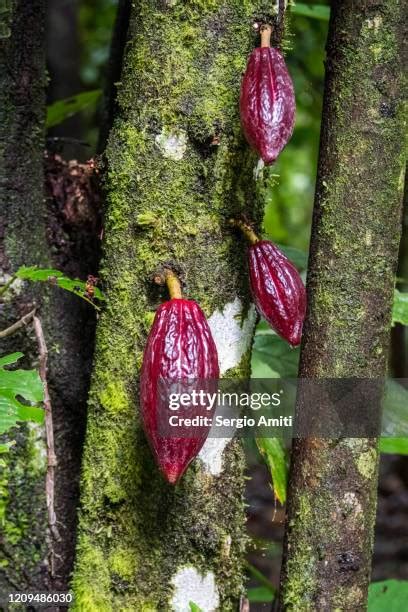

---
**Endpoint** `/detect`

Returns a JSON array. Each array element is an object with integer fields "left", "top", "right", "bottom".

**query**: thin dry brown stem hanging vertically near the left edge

[{"left": 33, "top": 316, "right": 61, "bottom": 541}]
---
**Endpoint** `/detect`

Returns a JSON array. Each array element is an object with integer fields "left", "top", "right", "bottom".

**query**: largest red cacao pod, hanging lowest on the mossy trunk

[{"left": 140, "top": 298, "right": 219, "bottom": 484}]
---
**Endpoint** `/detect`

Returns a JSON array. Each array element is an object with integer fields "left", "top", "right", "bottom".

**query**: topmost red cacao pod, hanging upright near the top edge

[{"left": 240, "top": 41, "right": 295, "bottom": 164}]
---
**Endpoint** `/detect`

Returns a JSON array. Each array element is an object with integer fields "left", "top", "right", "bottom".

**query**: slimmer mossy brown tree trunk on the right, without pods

[{"left": 281, "top": 0, "right": 404, "bottom": 611}]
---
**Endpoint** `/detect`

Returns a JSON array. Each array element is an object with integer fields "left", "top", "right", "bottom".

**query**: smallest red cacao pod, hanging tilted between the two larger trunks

[{"left": 248, "top": 240, "right": 306, "bottom": 346}]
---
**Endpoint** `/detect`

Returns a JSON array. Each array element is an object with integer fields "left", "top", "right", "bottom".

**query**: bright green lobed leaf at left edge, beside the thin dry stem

[{"left": 0, "top": 353, "right": 44, "bottom": 440}]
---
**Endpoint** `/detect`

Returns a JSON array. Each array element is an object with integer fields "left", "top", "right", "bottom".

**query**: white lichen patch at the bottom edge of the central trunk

[{"left": 171, "top": 566, "right": 220, "bottom": 612}]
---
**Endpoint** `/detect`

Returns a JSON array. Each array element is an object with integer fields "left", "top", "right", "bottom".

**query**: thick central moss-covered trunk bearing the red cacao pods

[{"left": 73, "top": 0, "right": 286, "bottom": 611}]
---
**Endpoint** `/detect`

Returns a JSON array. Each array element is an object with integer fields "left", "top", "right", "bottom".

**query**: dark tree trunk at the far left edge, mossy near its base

[{"left": 0, "top": 0, "right": 47, "bottom": 593}]
